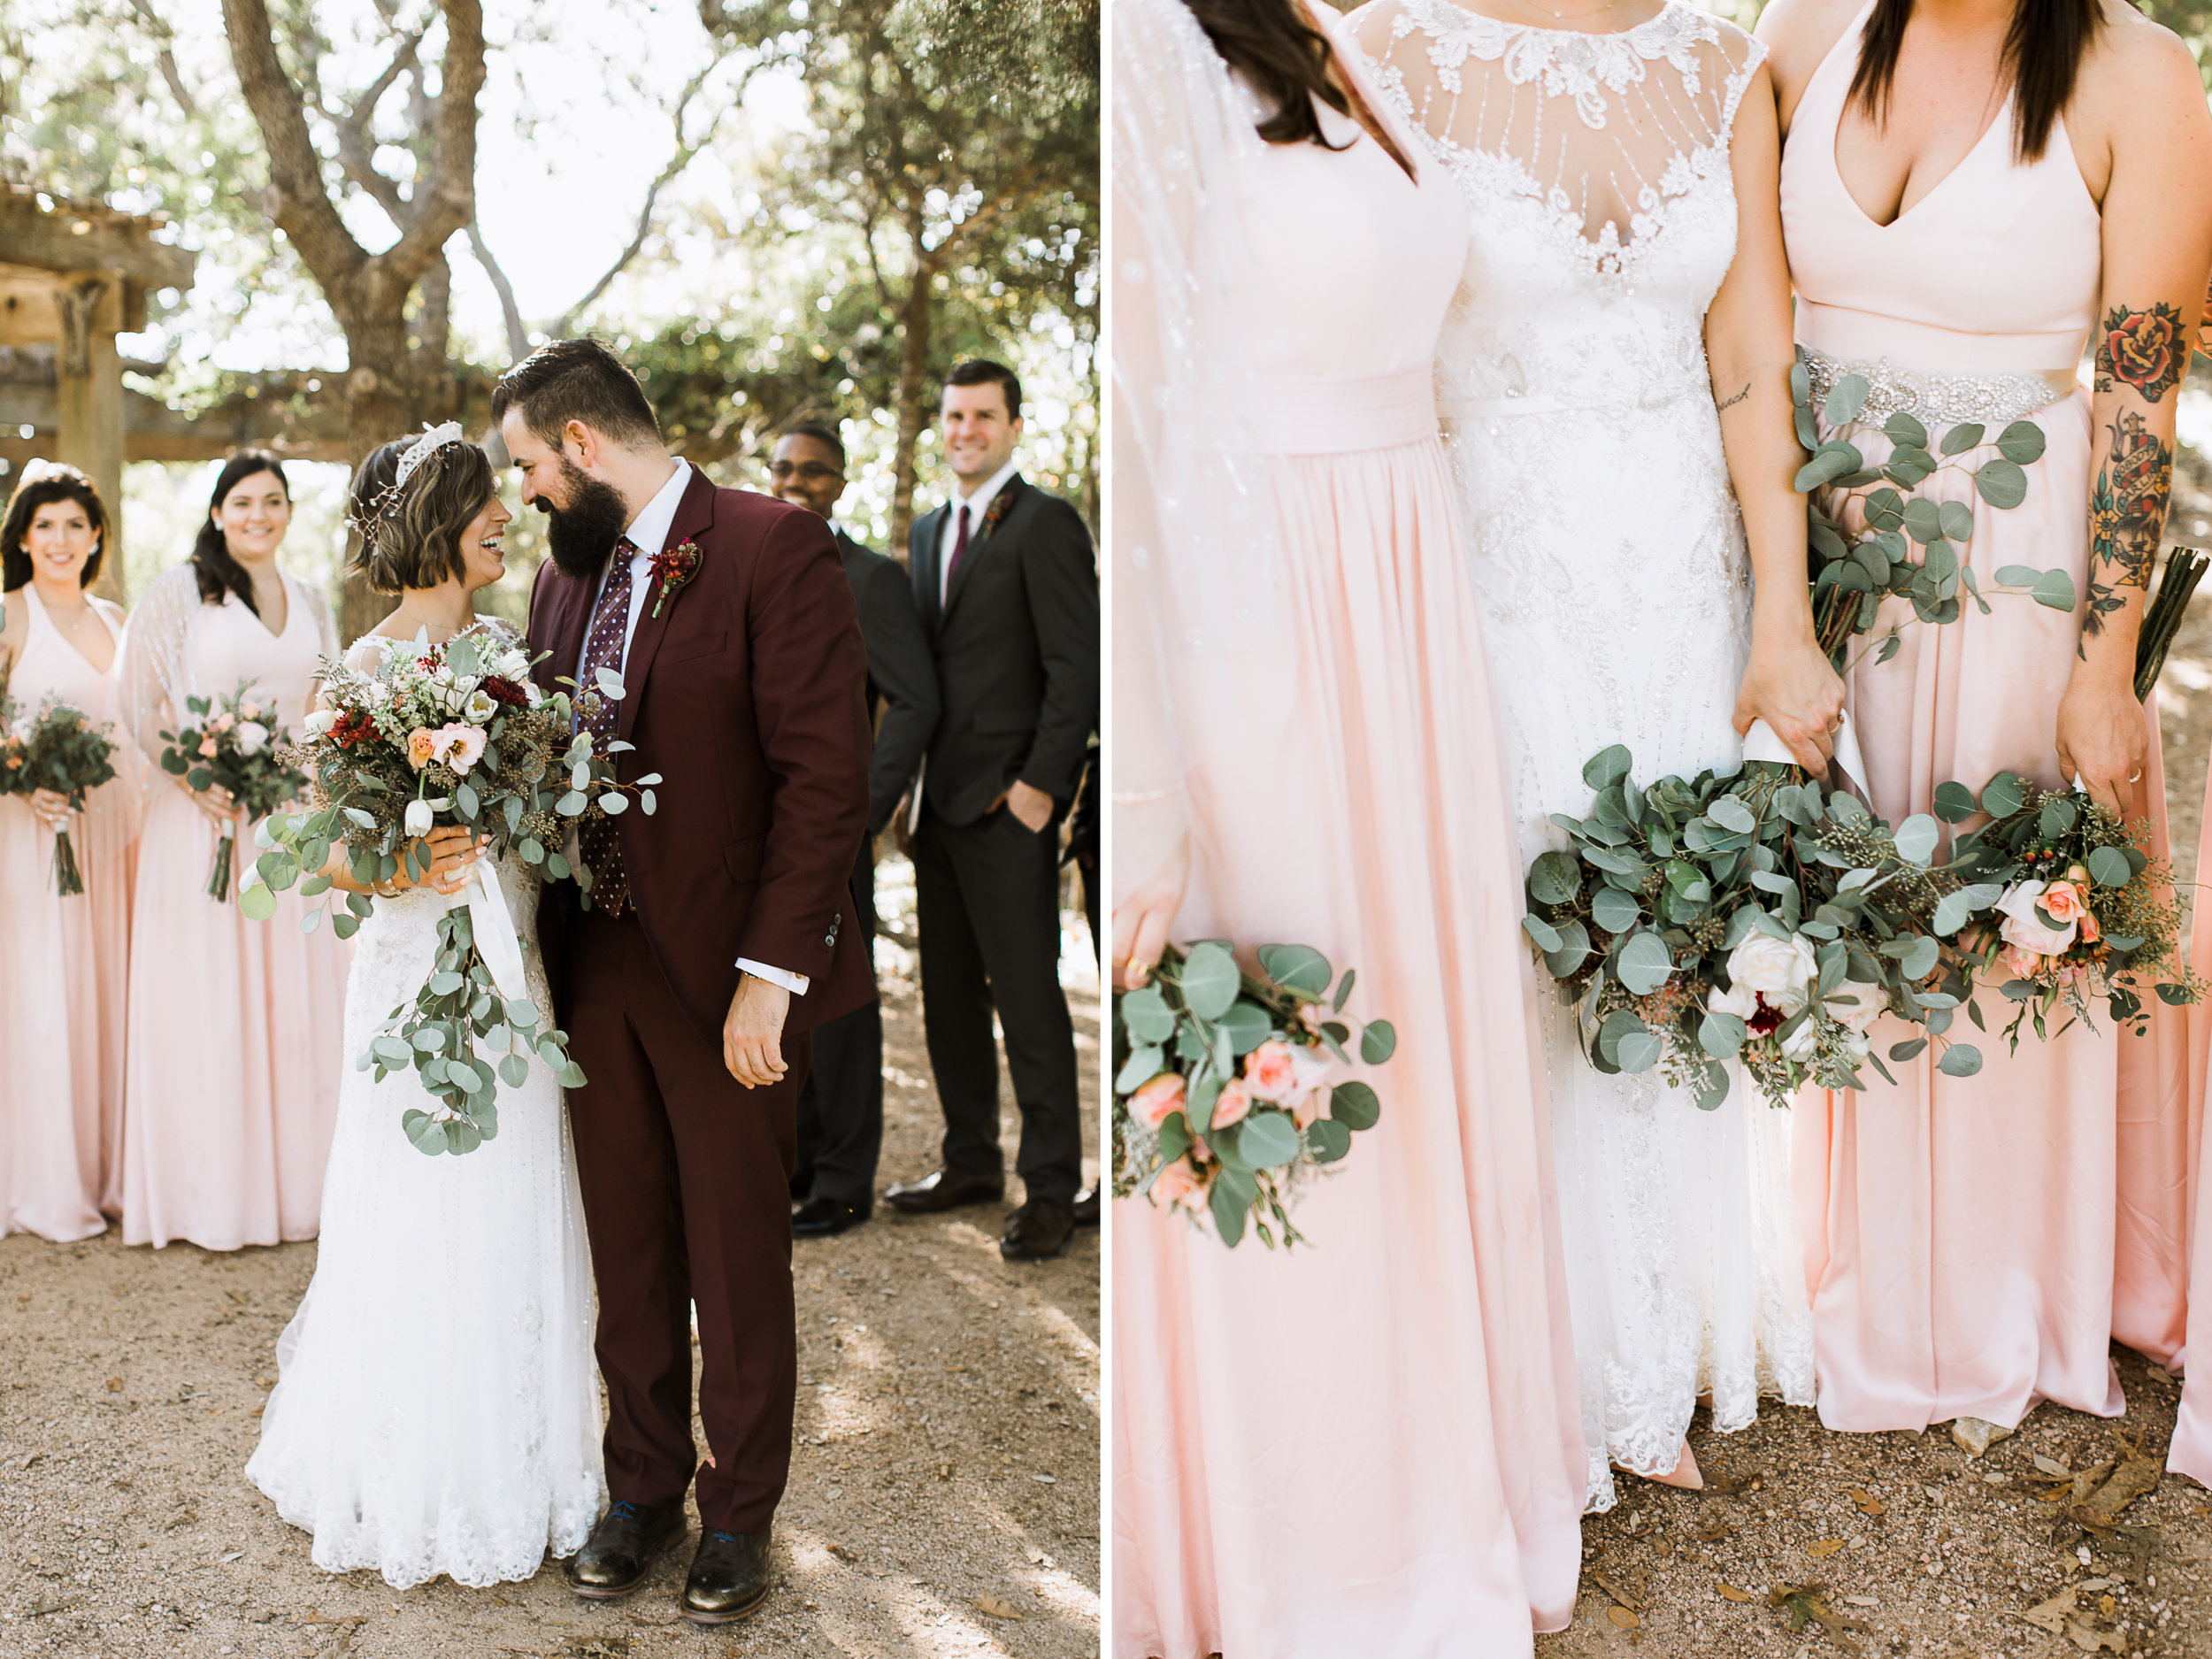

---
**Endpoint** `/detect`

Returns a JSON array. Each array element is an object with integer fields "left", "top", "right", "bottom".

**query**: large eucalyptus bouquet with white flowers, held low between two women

[{"left": 1522, "top": 743, "right": 2004, "bottom": 1110}]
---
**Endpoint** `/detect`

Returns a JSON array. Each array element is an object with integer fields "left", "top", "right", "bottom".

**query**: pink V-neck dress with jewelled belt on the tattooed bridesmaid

[{"left": 1781, "top": 7, "right": 2194, "bottom": 1429}]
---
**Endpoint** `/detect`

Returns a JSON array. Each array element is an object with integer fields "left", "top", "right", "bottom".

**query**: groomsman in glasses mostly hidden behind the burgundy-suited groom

[{"left": 768, "top": 427, "right": 938, "bottom": 1239}]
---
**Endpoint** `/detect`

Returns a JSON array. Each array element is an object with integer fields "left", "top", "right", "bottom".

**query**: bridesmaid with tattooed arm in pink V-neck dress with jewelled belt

[{"left": 1759, "top": 0, "right": 2212, "bottom": 1451}]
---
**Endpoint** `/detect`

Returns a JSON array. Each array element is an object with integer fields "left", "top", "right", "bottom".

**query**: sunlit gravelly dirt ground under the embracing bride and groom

[{"left": 0, "top": 863, "right": 1102, "bottom": 1659}]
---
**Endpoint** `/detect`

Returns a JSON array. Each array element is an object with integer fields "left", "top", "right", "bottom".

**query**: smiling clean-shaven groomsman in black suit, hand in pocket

[{"left": 885, "top": 361, "right": 1100, "bottom": 1261}]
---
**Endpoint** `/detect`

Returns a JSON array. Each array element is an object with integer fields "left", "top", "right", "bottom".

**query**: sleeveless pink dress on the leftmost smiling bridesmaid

[{"left": 0, "top": 587, "right": 137, "bottom": 1241}]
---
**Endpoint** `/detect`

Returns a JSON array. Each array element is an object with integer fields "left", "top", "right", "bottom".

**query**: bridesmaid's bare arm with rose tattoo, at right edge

[{"left": 2057, "top": 18, "right": 2212, "bottom": 808}]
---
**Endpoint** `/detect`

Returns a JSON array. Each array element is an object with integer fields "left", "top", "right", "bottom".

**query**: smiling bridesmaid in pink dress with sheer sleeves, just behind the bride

[{"left": 124, "top": 451, "right": 352, "bottom": 1250}]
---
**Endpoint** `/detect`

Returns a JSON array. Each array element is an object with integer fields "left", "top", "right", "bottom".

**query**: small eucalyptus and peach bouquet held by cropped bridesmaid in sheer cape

[{"left": 1113, "top": 941, "right": 1398, "bottom": 1250}]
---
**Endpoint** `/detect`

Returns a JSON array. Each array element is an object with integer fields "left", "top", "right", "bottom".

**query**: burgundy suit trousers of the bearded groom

[{"left": 565, "top": 910, "right": 808, "bottom": 1533}]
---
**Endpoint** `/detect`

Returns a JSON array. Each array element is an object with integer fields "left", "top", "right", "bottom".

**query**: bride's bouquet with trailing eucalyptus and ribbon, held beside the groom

[{"left": 239, "top": 631, "right": 659, "bottom": 1153}]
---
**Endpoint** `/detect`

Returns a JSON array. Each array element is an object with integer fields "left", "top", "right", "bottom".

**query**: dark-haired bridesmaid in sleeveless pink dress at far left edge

[{"left": 0, "top": 463, "right": 137, "bottom": 1241}]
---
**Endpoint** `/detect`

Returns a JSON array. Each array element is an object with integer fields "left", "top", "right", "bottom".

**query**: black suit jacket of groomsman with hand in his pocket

[{"left": 907, "top": 473, "right": 1100, "bottom": 823}]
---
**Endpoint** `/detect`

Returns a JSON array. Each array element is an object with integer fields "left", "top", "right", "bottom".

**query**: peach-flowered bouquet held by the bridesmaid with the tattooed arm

[{"left": 1936, "top": 772, "right": 2206, "bottom": 1051}]
